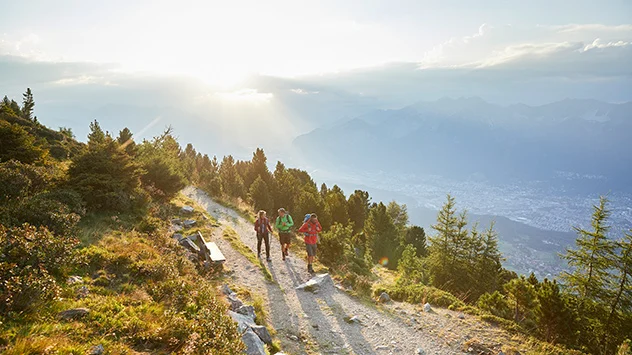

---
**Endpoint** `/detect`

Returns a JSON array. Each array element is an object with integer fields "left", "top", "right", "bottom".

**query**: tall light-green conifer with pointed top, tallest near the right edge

[{"left": 561, "top": 197, "right": 613, "bottom": 301}]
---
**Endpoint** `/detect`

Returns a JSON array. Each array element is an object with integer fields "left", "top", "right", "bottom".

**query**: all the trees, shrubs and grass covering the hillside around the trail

[{"left": 0, "top": 90, "right": 632, "bottom": 354}]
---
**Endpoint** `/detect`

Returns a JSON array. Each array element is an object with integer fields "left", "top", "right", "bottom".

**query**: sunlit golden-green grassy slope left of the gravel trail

[{"left": 0, "top": 197, "right": 243, "bottom": 354}]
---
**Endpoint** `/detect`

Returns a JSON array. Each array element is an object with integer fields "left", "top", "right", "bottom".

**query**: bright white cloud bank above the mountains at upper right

[{"left": 420, "top": 24, "right": 632, "bottom": 77}]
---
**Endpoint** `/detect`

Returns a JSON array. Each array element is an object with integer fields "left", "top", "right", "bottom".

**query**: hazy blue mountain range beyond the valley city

[{"left": 293, "top": 98, "right": 632, "bottom": 193}]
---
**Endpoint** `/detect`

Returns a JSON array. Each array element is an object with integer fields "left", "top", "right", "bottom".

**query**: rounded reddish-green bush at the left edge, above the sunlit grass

[{"left": 0, "top": 224, "right": 78, "bottom": 312}]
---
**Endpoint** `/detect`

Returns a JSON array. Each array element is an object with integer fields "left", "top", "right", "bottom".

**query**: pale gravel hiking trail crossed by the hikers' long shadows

[{"left": 184, "top": 187, "right": 462, "bottom": 354}]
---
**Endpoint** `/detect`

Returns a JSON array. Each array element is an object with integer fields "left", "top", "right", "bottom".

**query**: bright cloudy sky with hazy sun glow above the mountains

[{"left": 0, "top": 0, "right": 632, "bottom": 154}]
